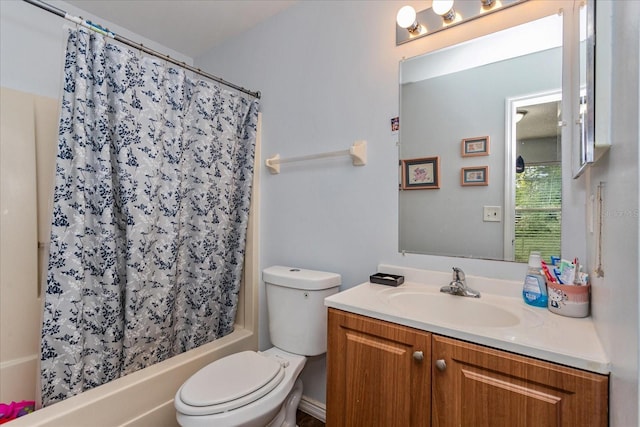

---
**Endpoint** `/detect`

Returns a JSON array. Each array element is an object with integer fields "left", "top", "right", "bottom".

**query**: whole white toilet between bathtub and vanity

[{"left": 174, "top": 266, "right": 341, "bottom": 427}]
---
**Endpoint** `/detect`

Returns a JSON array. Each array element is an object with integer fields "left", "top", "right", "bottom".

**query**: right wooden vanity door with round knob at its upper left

[{"left": 432, "top": 335, "right": 608, "bottom": 427}]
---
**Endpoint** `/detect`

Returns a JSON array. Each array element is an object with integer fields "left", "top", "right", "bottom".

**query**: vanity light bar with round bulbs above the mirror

[{"left": 396, "top": 0, "right": 528, "bottom": 45}]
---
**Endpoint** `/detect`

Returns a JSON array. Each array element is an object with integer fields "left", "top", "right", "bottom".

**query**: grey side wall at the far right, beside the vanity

[{"left": 585, "top": 0, "right": 640, "bottom": 427}]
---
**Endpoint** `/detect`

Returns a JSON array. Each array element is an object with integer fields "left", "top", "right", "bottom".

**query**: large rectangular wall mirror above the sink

[{"left": 399, "top": 15, "right": 563, "bottom": 262}]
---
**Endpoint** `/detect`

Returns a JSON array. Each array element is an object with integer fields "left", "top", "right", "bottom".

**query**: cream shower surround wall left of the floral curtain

[{"left": 0, "top": 88, "right": 42, "bottom": 402}]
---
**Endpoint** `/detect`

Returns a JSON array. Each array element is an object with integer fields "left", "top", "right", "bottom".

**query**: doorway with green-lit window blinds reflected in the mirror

[{"left": 504, "top": 92, "right": 562, "bottom": 262}]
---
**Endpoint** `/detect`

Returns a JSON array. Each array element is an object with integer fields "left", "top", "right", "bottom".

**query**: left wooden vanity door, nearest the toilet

[{"left": 327, "top": 309, "right": 431, "bottom": 427}]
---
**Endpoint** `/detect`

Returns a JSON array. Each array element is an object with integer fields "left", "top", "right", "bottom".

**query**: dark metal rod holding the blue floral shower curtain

[{"left": 23, "top": 0, "right": 261, "bottom": 99}]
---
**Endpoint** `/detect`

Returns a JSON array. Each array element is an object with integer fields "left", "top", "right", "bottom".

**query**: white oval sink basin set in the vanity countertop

[{"left": 383, "top": 289, "right": 542, "bottom": 328}]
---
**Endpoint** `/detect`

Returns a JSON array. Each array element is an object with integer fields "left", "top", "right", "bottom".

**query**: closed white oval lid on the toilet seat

[{"left": 180, "top": 351, "right": 284, "bottom": 414}]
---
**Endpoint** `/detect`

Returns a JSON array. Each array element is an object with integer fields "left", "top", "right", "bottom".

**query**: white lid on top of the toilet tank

[{"left": 262, "top": 265, "right": 342, "bottom": 291}]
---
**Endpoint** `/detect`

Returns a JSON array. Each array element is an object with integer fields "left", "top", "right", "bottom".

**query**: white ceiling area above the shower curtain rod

[{"left": 67, "top": 0, "right": 296, "bottom": 58}]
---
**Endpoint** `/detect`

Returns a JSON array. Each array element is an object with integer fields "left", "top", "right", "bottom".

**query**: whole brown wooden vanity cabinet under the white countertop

[{"left": 327, "top": 308, "right": 608, "bottom": 427}]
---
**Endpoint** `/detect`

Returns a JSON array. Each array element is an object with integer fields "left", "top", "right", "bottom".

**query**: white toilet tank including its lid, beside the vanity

[{"left": 262, "top": 265, "right": 341, "bottom": 356}]
